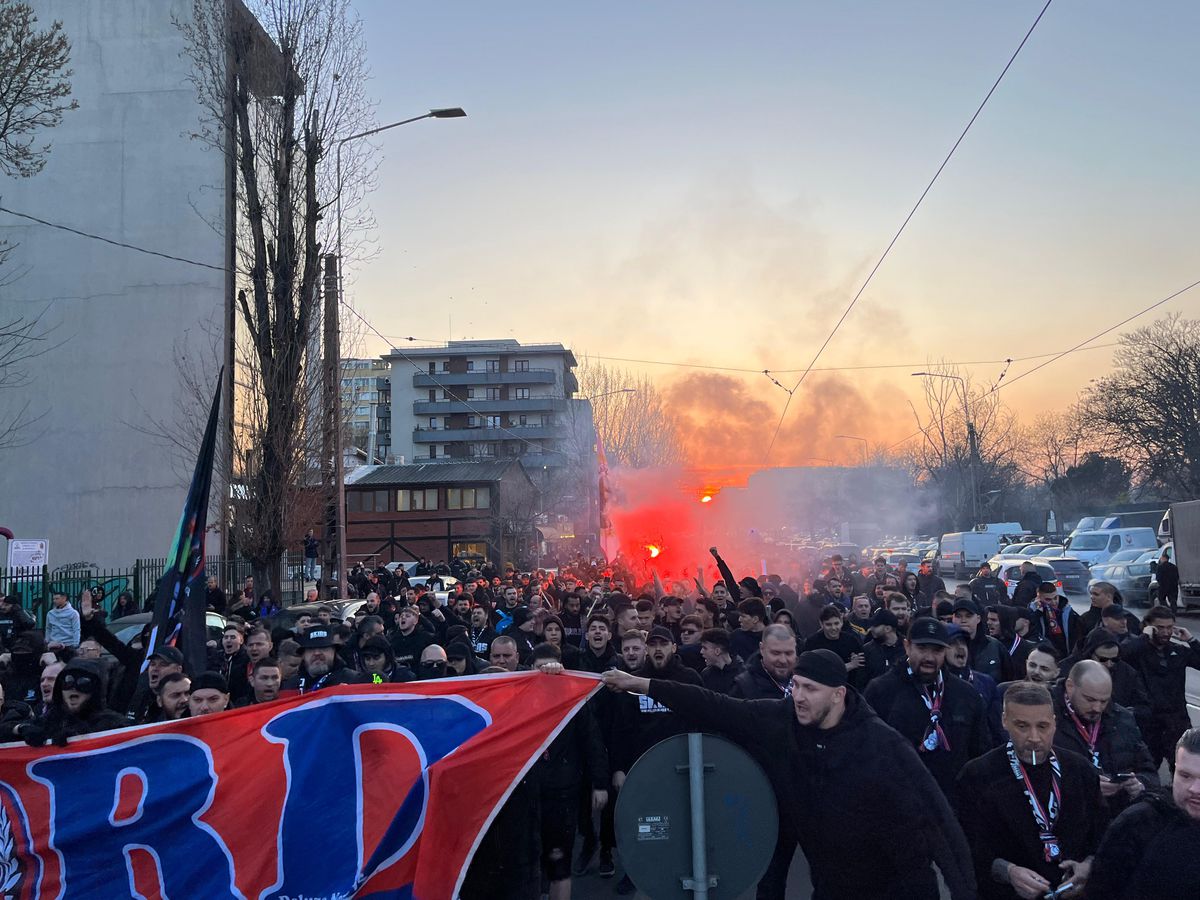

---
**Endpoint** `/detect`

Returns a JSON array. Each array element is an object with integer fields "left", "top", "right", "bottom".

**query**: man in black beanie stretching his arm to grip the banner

[{"left": 604, "top": 650, "right": 976, "bottom": 900}]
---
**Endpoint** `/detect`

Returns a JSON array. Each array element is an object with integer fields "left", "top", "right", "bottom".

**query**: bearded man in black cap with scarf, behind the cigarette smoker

[{"left": 863, "top": 618, "right": 991, "bottom": 803}]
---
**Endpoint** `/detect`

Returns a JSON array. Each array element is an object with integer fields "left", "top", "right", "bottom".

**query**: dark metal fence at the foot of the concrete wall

[{"left": 0, "top": 556, "right": 305, "bottom": 625}]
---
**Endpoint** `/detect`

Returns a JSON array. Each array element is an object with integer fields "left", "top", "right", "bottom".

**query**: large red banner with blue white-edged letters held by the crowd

[{"left": 0, "top": 673, "right": 599, "bottom": 900}]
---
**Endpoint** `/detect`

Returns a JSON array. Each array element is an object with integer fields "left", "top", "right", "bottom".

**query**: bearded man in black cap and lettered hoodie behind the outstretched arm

[{"left": 610, "top": 628, "right": 700, "bottom": 894}]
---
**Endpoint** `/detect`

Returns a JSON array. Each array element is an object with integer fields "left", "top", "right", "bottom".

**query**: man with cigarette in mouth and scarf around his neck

[{"left": 958, "top": 683, "right": 1108, "bottom": 900}]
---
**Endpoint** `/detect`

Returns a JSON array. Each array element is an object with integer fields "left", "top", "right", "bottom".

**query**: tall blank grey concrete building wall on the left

[{"left": 0, "top": 0, "right": 224, "bottom": 566}]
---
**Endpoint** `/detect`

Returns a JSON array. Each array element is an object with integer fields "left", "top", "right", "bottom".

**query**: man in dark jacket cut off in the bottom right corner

[{"left": 1087, "top": 728, "right": 1200, "bottom": 900}]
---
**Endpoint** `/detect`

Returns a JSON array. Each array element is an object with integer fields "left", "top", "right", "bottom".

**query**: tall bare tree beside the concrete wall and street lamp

[{"left": 180, "top": 0, "right": 372, "bottom": 600}]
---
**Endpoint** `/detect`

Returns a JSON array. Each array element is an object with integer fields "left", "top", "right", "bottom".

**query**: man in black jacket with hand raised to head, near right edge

[{"left": 1121, "top": 606, "right": 1200, "bottom": 768}]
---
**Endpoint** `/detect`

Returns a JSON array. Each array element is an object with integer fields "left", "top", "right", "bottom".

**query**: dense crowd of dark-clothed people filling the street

[{"left": 0, "top": 547, "right": 1200, "bottom": 900}]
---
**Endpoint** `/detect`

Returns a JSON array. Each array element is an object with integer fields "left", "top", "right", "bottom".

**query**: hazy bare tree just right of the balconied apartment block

[{"left": 578, "top": 355, "right": 688, "bottom": 469}]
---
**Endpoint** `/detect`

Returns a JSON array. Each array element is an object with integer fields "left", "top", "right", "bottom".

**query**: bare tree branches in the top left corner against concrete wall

[{"left": 0, "top": 0, "right": 79, "bottom": 178}]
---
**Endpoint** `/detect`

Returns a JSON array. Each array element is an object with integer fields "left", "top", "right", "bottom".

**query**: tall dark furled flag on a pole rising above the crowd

[{"left": 142, "top": 368, "right": 224, "bottom": 674}]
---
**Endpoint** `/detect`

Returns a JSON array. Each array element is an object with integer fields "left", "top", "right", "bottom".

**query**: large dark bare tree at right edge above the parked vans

[{"left": 1085, "top": 313, "right": 1200, "bottom": 499}]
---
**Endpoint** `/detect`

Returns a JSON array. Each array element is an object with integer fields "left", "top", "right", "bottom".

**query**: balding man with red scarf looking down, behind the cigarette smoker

[{"left": 1051, "top": 660, "right": 1159, "bottom": 816}]
